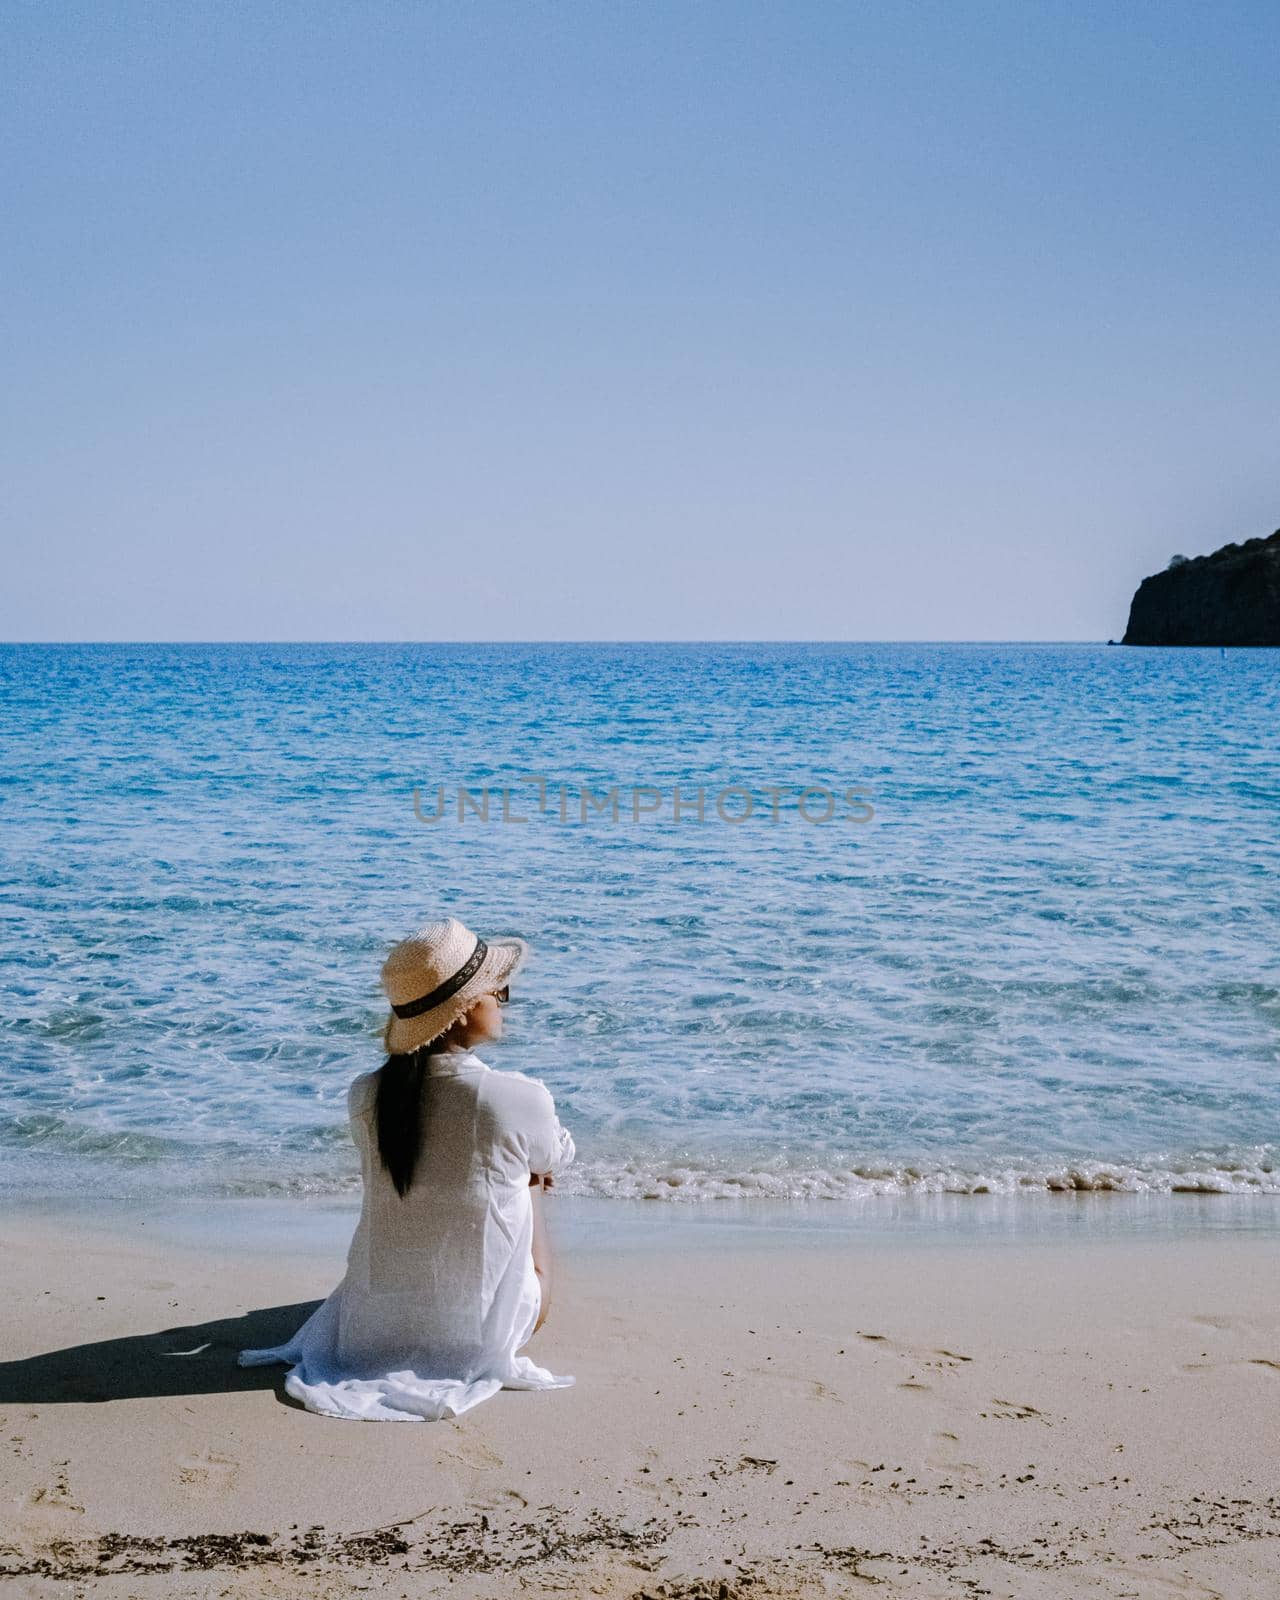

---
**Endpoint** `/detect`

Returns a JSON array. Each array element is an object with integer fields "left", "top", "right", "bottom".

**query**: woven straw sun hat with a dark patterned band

[{"left": 382, "top": 917, "right": 528, "bottom": 1056}]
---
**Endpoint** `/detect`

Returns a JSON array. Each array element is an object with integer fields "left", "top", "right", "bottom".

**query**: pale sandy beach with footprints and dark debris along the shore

[{"left": 0, "top": 1200, "right": 1280, "bottom": 1600}]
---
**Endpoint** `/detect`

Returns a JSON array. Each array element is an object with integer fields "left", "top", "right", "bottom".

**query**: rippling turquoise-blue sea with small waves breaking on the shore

[{"left": 0, "top": 645, "right": 1280, "bottom": 1203}]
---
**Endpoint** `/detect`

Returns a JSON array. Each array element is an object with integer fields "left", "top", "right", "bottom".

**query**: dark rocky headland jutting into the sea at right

[{"left": 1120, "top": 528, "right": 1280, "bottom": 645}]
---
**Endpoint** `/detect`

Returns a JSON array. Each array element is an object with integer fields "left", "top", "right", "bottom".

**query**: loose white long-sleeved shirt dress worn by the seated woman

[{"left": 238, "top": 1050, "right": 574, "bottom": 1422}]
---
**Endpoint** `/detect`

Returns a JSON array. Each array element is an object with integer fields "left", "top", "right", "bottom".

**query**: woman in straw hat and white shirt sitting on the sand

[{"left": 240, "top": 917, "right": 574, "bottom": 1422}]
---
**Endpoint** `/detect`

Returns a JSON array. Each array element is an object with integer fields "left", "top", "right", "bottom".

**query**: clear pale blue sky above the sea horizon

[{"left": 0, "top": 0, "right": 1280, "bottom": 638}]
